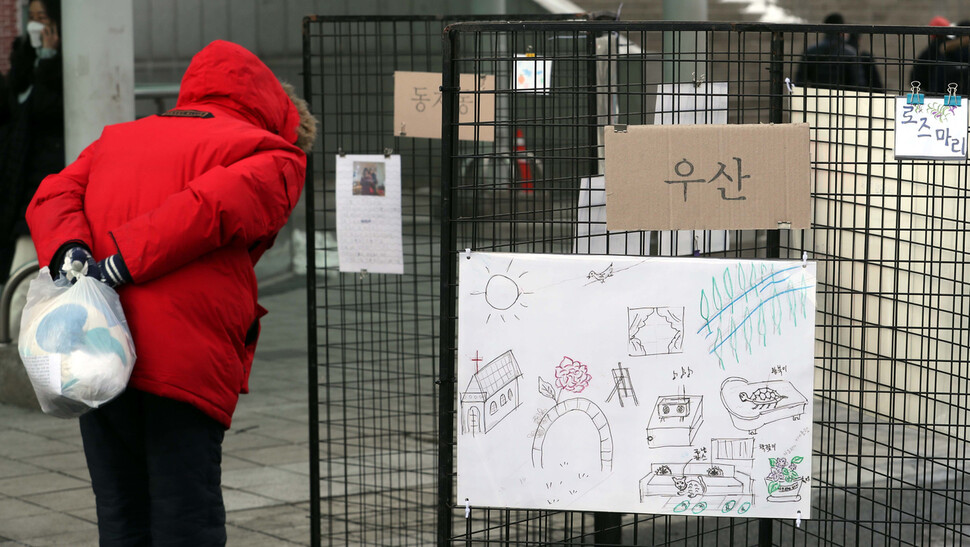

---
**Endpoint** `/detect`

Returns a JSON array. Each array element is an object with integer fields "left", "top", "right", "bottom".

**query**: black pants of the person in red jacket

[{"left": 80, "top": 388, "right": 226, "bottom": 547}]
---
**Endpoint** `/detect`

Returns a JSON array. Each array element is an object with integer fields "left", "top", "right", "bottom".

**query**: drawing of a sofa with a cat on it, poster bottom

[{"left": 640, "top": 462, "right": 751, "bottom": 502}]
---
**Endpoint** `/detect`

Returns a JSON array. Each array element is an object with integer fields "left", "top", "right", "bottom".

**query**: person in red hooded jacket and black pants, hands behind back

[{"left": 27, "top": 41, "right": 315, "bottom": 547}]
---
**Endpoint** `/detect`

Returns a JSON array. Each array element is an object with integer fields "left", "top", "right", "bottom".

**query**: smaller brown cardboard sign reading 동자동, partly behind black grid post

[{"left": 394, "top": 71, "right": 495, "bottom": 142}]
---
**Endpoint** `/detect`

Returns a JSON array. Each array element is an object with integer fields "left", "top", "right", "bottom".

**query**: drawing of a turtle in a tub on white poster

[{"left": 721, "top": 376, "right": 808, "bottom": 435}]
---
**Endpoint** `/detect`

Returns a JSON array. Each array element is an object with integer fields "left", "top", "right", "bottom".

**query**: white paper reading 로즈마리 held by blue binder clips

[{"left": 894, "top": 97, "right": 970, "bottom": 160}]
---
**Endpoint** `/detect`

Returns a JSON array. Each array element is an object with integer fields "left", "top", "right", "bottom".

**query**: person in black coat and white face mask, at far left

[{"left": 0, "top": 0, "right": 64, "bottom": 285}]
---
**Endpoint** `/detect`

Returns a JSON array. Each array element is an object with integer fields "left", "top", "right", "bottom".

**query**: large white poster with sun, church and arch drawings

[{"left": 457, "top": 253, "right": 816, "bottom": 518}]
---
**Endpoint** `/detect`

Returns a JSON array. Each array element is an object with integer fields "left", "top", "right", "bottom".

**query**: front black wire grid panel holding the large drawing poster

[{"left": 438, "top": 21, "right": 970, "bottom": 546}]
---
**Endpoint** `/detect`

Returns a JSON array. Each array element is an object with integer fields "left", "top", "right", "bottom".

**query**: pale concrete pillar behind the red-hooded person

[{"left": 61, "top": 0, "right": 135, "bottom": 163}]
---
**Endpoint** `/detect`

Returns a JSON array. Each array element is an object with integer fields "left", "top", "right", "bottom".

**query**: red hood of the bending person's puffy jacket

[{"left": 176, "top": 40, "right": 300, "bottom": 143}]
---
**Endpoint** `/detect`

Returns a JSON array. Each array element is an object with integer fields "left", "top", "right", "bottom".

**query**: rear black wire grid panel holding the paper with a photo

[{"left": 303, "top": 14, "right": 596, "bottom": 545}]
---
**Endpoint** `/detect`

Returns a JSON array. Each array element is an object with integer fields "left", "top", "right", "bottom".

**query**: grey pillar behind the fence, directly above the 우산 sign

[{"left": 663, "top": 0, "right": 707, "bottom": 82}]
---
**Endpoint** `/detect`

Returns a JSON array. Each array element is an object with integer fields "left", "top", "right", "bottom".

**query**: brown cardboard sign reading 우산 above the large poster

[{"left": 606, "top": 124, "right": 811, "bottom": 230}]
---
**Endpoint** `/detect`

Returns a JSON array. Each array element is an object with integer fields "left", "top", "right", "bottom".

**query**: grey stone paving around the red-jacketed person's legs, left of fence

[{"left": 0, "top": 276, "right": 310, "bottom": 547}]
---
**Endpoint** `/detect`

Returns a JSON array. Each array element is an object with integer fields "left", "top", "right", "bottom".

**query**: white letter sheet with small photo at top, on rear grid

[{"left": 336, "top": 154, "right": 404, "bottom": 274}]
